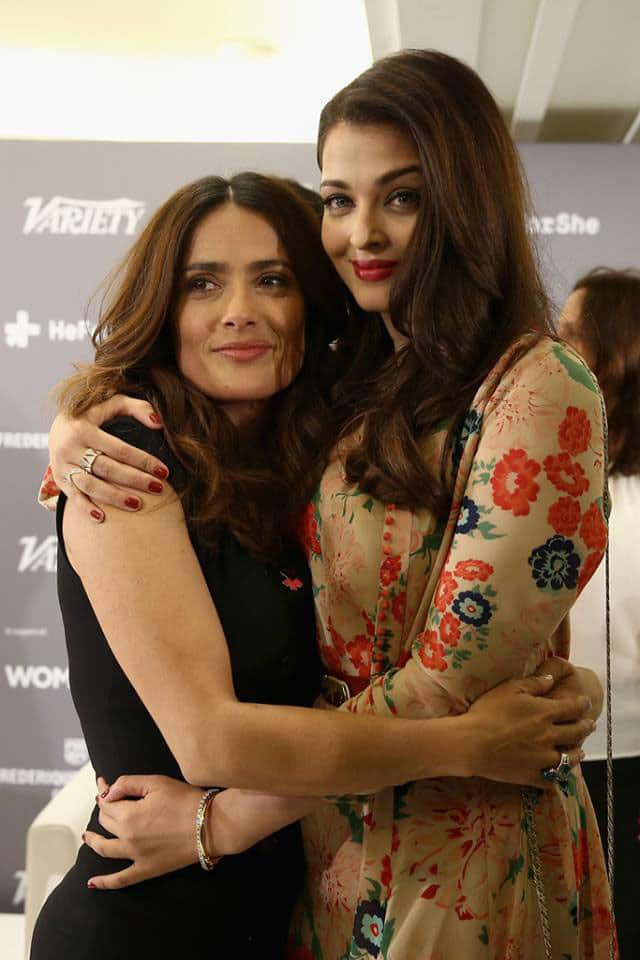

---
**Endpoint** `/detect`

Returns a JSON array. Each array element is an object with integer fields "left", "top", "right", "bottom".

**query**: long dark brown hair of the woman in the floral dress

[{"left": 318, "top": 50, "right": 551, "bottom": 516}]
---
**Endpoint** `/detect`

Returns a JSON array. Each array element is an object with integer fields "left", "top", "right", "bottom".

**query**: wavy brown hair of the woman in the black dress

[{"left": 57, "top": 173, "right": 345, "bottom": 560}]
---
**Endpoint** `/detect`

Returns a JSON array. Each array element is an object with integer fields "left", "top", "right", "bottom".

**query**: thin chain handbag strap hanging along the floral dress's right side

[{"left": 521, "top": 391, "right": 616, "bottom": 960}]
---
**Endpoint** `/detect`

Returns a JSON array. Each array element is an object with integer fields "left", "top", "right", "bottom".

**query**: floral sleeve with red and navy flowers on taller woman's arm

[{"left": 324, "top": 341, "right": 607, "bottom": 717}]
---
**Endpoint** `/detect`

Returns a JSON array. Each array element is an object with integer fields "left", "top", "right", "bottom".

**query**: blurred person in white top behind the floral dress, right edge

[{"left": 559, "top": 267, "right": 640, "bottom": 957}]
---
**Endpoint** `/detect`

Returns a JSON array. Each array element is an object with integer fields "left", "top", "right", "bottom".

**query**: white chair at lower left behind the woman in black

[{"left": 24, "top": 763, "right": 96, "bottom": 960}]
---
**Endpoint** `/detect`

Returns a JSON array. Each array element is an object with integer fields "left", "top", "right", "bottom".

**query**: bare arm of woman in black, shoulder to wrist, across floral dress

[{"left": 64, "top": 489, "right": 471, "bottom": 795}]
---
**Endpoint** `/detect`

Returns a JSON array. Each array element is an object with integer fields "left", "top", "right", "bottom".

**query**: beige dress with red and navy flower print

[{"left": 290, "top": 337, "right": 611, "bottom": 960}]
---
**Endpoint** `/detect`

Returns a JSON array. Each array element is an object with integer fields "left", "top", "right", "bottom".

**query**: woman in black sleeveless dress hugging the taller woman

[{"left": 31, "top": 174, "right": 589, "bottom": 960}]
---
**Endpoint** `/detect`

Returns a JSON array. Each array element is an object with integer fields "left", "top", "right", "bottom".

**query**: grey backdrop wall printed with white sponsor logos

[{"left": 0, "top": 141, "right": 640, "bottom": 912}]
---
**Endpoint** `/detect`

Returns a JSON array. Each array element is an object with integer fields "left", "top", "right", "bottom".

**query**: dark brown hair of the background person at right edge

[{"left": 573, "top": 267, "right": 640, "bottom": 476}]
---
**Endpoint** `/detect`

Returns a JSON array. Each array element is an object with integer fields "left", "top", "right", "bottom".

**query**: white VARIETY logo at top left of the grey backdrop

[{"left": 22, "top": 197, "right": 146, "bottom": 237}]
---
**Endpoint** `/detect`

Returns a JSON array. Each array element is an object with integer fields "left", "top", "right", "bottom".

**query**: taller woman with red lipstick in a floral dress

[{"left": 42, "top": 51, "right": 611, "bottom": 960}]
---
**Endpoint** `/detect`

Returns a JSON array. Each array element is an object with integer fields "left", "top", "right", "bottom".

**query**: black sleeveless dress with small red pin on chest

[{"left": 31, "top": 417, "right": 321, "bottom": 960}]
